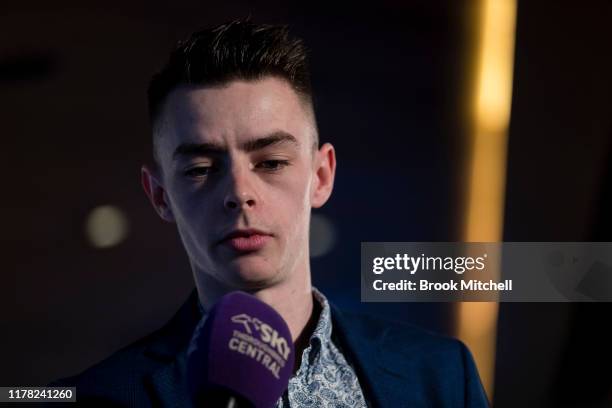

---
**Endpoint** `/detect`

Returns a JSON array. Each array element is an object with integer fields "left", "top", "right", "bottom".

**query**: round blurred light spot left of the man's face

[{"left": 85, "top": 205, "right": 128, "bottom": 248}]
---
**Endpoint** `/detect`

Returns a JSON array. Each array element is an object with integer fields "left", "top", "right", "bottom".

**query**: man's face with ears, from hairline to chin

[{"left": 143, "top": 77, "right": 335, "bottom": 289}]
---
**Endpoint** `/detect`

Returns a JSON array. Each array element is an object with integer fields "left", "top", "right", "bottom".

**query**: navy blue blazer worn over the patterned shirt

[{"left": 50, "top": 290, "right": 488, "bottom": 408}]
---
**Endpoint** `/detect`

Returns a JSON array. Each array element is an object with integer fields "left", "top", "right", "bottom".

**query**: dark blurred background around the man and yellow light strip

[{"left": 0, "top": 0, "right": 612, "bottom": 407}]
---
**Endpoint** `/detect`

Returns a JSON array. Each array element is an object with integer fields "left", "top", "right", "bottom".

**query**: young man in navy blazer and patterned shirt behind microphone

[{"left": 56, "top": 21, "right": 487, "bottom": 407}]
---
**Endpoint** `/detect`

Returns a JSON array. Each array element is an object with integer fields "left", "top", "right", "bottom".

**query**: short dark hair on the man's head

[{"left": 147, "top": 19, "right": 317, "bottom": 140}]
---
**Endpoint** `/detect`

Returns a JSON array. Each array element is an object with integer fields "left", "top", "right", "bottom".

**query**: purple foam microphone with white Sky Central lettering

[{"left": 187, "top": 292, "right": 294, "bottom": 408}]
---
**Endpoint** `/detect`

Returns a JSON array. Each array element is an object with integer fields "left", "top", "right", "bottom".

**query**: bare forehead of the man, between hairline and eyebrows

[{"left": 159, "top": 78, "right": 312, "bottom": 154}]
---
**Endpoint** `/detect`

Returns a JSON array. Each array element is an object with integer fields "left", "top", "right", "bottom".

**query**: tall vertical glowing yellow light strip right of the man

[{"left": 457, "top": 0, "right": 516, "bottom": 401}]
